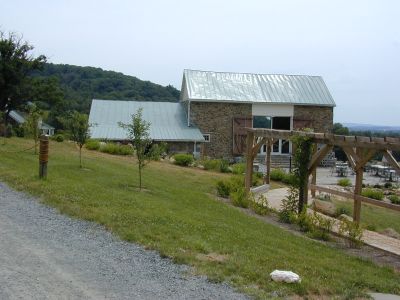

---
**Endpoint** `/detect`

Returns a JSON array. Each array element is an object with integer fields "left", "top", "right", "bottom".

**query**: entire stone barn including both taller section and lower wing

[{"left": 89, "top": 70, "right": 335, "bottom": 160}]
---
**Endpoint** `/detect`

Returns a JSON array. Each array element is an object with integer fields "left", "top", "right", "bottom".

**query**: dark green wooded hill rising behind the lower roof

[{"left": 33, "top": 63, "right": 180, "bottom": 113}]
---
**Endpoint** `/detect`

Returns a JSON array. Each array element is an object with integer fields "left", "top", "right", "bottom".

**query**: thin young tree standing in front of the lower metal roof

[{"left": 118, "top": 108, "right": 151, "bottom": 190}]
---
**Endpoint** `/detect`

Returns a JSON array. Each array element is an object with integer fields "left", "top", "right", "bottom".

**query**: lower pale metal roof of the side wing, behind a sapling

[{"left": 89, "top": 99, "right": 204, "bottom": 142}]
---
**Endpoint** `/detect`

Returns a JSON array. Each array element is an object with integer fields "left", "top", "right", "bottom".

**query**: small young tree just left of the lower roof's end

[{"left": 66, "top": 111, "right": 90, "bottom": 168}]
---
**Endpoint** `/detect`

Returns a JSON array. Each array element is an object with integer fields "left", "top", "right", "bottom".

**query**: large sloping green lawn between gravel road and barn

[{"left": 0, "top": 138, "right": 400, "bottom": 298}]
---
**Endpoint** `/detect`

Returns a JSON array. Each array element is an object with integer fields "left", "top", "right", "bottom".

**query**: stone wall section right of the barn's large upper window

[{"left": 293, "top": 105, "right": 333, "bottom": 132}]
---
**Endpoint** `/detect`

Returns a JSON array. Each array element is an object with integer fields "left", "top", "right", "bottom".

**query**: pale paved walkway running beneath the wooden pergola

[{"left": 264, "top": 188, "right": 400, "bottom": 256}]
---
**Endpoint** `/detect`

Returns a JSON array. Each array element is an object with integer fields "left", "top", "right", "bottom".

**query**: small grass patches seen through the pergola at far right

[{"left": 332, "top": 199, "right": 400, "bottom": 233}]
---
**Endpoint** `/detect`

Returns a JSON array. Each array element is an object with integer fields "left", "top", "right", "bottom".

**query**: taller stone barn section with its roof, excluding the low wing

[{"left": 181, "top": 70, "right": 335, "bottom": 158}]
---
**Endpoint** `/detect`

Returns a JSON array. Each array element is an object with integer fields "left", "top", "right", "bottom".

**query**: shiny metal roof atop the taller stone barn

[{"left": 182, "top": 70, "right": 336, "bottom": 106}]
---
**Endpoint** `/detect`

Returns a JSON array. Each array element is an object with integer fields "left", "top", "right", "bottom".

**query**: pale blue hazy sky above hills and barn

[{"left": 0, "top": 0, "right": 400, "bottom": 126}]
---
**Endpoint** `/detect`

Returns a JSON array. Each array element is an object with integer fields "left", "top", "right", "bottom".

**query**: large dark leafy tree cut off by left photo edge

[{"left": 0, "top": 32, "right": 46, "bottom": 136}]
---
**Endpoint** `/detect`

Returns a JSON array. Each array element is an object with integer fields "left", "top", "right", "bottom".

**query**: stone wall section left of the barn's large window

[{"left": 190, "top": 102, "right": 251, "bottom": 158}]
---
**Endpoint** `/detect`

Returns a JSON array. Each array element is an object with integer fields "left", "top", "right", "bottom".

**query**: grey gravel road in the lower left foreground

[{"left": 0, "top": 183, "right": 247, "bottom": 299}]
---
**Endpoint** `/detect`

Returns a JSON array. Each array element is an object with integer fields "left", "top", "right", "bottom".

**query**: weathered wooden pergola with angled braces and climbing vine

[{"left": 245, "top": 128, "right": 400, "bottom": 222}]
